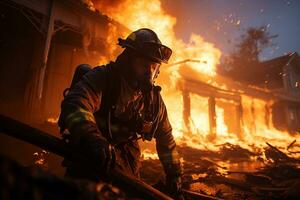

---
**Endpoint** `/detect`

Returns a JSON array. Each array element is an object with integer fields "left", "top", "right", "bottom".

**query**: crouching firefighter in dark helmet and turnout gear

[{"left": 59, "top": 28, "right": 182, "bottom": 198}]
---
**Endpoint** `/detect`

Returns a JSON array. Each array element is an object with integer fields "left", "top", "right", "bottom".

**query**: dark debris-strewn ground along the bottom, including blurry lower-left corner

[{"left": 0, "top": 141, "right": 300, "bottom": 200}]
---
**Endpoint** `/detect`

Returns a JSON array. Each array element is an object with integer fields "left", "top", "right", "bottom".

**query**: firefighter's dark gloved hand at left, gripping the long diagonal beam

[{"left": 80, "top": 132, "right": 115, "bottom": 172}]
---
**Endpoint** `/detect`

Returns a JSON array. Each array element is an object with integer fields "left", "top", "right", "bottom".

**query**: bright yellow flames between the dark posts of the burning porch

[{"left": 184, "top": 95, "right": 300, "bottom": 153}]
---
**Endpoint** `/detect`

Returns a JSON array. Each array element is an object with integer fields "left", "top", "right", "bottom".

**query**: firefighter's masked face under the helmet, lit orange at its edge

[{"left": 132, "top": 57, "right": 160, "bottom": 85}]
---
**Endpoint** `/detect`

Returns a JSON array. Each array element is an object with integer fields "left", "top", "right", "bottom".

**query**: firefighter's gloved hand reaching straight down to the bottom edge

[{"left": 166, "top": 175, "right": 184, "bottom": 200}]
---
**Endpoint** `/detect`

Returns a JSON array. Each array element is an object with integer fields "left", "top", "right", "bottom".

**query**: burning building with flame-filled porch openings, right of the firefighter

[{"left": 178, "top": 53, "right": 300, "bottom": 148}]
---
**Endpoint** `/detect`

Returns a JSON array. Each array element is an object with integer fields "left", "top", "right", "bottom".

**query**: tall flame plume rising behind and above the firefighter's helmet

[{"left": 89, "top": 0, "right": 221, "bottom": 75}]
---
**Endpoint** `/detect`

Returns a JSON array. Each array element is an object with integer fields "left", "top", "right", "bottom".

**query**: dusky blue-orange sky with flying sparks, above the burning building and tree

[{"left": 162, "top": 0, "right": 300, "bottom": 60}]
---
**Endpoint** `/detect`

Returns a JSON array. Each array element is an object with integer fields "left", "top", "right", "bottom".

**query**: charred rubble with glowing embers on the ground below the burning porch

[{"left": 141, "top": 142, "right": 300, "bottom": 200}]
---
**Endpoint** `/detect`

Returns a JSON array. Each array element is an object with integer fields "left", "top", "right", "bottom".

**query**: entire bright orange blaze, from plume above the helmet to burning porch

[{"left": 85, "top": 0, "right": 296, "bottom": 157}]
